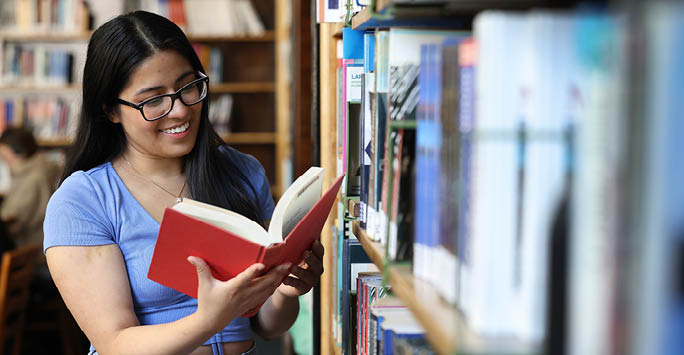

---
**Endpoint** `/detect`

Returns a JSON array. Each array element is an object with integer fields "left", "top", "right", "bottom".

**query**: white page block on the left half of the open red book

[{"left": 172, "top": 198, "right": 276, "bottom": 245}]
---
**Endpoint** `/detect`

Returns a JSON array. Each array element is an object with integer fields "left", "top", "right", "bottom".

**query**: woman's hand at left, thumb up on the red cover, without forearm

[{"left": 188, "top": 256, "right": 292, "bottom": 332}]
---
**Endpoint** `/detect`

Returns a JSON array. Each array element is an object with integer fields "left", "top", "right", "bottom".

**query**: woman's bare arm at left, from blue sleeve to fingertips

[{"left": 46, "top": 244, "right": 290, "bottom": 354}]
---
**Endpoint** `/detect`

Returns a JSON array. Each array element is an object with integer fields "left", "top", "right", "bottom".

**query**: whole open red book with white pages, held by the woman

[{"left": 147, "top": 167, "right": 342, "bottom": 318}]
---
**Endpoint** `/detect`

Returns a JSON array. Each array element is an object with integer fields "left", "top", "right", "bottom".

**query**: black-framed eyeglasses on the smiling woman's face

[{"left": 117, "top": 71, "right": 209, "bottom": 121}]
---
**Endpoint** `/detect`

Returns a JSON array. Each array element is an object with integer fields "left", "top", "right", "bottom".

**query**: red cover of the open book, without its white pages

[{"left": 147, "top": 177, "right": 342, "bottom": 316}]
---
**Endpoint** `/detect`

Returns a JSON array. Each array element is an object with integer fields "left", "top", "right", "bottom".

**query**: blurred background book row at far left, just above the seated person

[{"left": 0, "top": 95, "right": 77, "bottom": 140}]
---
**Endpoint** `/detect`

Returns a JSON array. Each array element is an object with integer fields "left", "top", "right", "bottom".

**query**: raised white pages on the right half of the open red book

[{"left": 268, "top": 167, "right": 323, "bottom": 241}]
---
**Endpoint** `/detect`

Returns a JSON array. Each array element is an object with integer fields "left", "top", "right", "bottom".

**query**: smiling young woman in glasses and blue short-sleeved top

[{"left": 44, "top": 11, "right": 323, "bottom": 354}]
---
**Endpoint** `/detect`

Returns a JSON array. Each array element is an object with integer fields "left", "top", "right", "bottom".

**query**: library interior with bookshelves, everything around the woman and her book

[{"left": 0, "top": 0, "right": 684, "bottom": 355}]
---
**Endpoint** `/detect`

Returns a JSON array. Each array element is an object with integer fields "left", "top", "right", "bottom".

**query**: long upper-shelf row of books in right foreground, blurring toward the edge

[{"left": 337, "top": 2, "right": 684, "bottom": 353}]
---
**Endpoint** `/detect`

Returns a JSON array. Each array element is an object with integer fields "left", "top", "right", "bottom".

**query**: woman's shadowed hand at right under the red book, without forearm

[{"left": 278, "top": 240, "right": 325, "bottom": 297}]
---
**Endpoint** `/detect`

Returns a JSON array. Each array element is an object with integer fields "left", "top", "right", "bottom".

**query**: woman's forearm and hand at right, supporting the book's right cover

[{"left": 252, "top": 241, "right": 324, "bottom": 339}]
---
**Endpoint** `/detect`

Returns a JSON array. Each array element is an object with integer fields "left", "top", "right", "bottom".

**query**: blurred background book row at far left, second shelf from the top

[{"left": 0, "top": 42, "right": 74, "bottom": 87}]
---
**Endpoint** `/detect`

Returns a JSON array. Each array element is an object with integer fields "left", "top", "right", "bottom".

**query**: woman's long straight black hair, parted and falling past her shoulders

[{"left": 61, "top": 11, "right": 264, "bottom": 224}]
